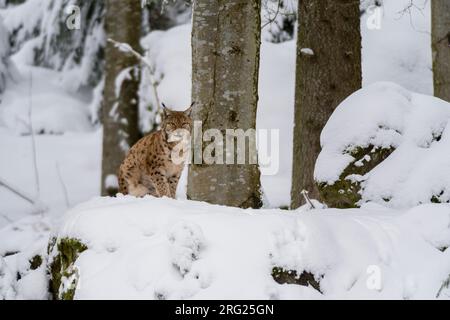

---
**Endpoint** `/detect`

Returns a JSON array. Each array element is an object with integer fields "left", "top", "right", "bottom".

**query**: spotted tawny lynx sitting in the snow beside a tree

[{"left": 119, "top": 104, "right": 194, "bottom": 198}]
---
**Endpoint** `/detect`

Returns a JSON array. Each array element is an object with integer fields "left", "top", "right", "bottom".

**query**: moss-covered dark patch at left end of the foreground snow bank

[{"left": 48, "top": 238, "right": 87, "bottom": 300}]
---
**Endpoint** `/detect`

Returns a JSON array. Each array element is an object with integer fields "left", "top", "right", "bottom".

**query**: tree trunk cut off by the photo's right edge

[{"left": 431, "top": 0, "right": 450, "bottom": 102}]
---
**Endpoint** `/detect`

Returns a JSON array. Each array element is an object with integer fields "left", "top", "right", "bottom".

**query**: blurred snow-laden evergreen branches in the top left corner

[{"left": 0, "top": 0, "right": 106, "bottom": 92}]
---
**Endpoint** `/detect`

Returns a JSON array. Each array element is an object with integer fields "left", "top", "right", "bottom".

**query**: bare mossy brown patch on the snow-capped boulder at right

[{"left": 317, "top": 145, "right": 394, "bottom": 209}]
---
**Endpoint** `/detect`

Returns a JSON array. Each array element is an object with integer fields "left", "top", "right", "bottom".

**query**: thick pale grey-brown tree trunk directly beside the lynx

[{"left": 188, "top": 0, "right": 261, "bottom": 208}]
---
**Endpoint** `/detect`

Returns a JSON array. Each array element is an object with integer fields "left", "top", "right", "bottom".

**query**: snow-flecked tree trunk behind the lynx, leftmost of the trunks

[{"left": 102, "top": 0, "right": 141, "bottom": 195}]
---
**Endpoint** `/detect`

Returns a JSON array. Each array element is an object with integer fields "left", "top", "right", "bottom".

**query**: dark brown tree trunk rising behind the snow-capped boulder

[{"left": 291, "top": 0, "right": 361, "bottom": 208}]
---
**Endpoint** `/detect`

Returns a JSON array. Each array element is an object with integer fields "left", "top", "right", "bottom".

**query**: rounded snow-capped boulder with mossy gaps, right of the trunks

[{"left": 314, "top": 82, "right": 450, "bottom": 208}]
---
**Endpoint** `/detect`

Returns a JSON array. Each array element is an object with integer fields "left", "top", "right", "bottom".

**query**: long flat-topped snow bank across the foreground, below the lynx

[{"left": 50, "top": 196, "right": 450, "bottom": 299}]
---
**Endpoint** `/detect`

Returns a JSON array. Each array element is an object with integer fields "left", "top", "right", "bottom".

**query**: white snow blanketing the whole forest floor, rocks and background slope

[{"left": 0, "top": 0, "right": 450, "bottom": 299}]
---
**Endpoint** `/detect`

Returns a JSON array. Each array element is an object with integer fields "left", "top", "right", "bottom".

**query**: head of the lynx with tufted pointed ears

[{"left": 161, "top": 102, "right": 195, "bottom": 142}]
